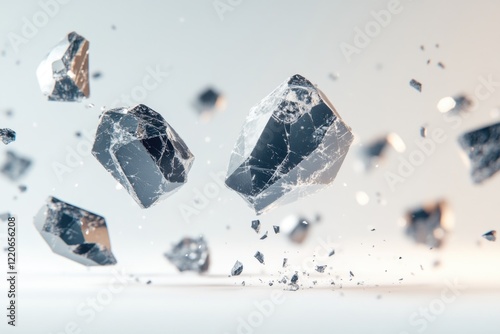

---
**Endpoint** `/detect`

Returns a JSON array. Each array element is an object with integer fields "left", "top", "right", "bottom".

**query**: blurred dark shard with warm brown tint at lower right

[{"left": 406, "top": 201, "right": 451, "bottom": 248}]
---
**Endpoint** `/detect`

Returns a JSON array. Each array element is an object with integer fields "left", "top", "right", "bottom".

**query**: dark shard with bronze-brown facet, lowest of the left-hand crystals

[{"left": 35, "top": 197, "right": 116, "bottom": 266}]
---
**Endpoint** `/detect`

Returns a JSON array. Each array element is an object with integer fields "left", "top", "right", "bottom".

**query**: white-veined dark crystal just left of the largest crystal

[{"left": 92, "top": 104, "right": 194, "bottom": 208}]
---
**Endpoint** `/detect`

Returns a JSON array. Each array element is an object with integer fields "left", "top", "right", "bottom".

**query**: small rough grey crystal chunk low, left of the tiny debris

[{"left": 165, "top": 236, "right": 210, "bottom": 273}]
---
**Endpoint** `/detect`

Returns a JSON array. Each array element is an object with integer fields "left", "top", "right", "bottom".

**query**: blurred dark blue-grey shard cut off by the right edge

[{"left": 458, "top": 123, "right": 500, "bottom": 183}]
